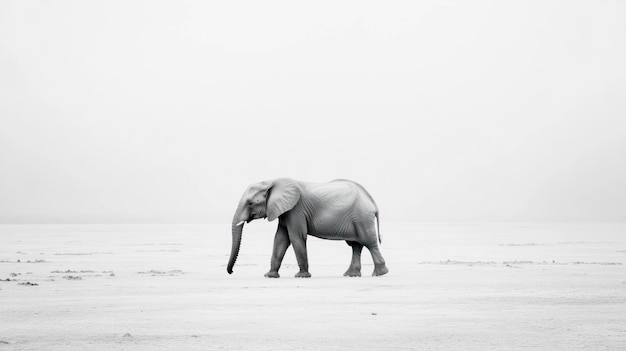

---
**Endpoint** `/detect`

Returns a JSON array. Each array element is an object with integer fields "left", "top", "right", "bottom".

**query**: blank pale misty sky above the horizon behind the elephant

[{"left": 0, "top": 1, "right": 626, "bottom": 223}]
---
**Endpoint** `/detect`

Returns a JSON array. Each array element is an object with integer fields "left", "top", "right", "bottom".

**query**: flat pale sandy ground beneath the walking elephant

[{"left": 0, "top": 222, "right": 626, "bottom": 350}]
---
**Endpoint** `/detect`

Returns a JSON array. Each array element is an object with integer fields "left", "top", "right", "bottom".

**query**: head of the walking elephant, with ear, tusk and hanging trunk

[{"left": 226, "top": 178, "right": 300, "bottom": 274}]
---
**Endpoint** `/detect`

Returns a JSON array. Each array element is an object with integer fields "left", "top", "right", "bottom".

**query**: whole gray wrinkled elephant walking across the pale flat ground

[{"left": 227, "top": 178, "right": 388, "bottom": 278}]
